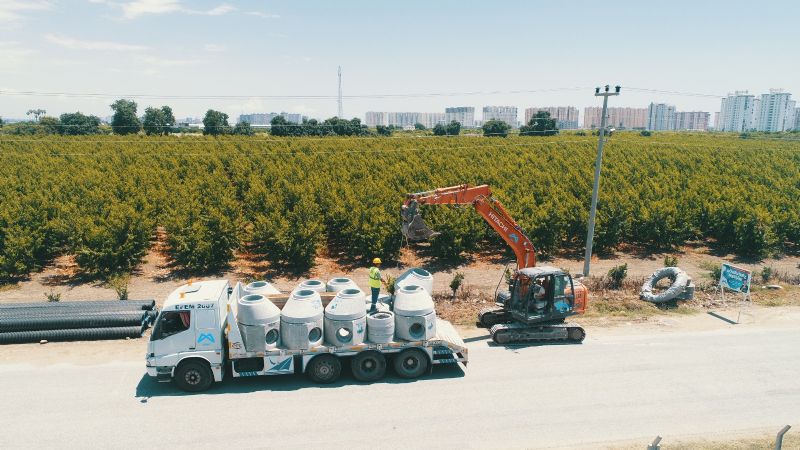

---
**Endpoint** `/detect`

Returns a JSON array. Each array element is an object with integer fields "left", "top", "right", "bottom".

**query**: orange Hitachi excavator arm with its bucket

[{"left": 400, "top": 184, "right": 536, "bottom": 269}]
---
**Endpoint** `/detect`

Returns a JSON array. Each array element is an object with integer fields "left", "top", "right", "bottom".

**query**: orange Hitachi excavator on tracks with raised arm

[{"left": 400, "top": 184, "right": 588, "bottom": 345}]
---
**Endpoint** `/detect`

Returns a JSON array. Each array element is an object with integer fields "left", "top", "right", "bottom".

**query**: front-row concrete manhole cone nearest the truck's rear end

[{"left": 394, "top": 284, "right": 436, "bottom": 341}]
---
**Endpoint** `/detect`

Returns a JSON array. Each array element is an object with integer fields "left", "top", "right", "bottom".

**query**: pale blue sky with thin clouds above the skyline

[{"left": 0, "top": 0, "right": 800, "bottom": 120}]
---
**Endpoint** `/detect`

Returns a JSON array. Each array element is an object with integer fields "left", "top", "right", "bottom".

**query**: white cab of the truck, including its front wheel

[{"left": 146, "top": 280, "right": 230, "bottom": 391}]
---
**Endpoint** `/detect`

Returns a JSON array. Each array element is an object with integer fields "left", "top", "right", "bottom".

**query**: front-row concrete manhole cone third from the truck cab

[{"left": 325, "top": 288, "right": 367, "bottom": 347}]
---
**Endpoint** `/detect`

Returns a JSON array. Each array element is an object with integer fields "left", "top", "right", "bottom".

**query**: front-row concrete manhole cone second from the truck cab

[{"left": 281, "top": 288, "right": 324, "bottom": 350}]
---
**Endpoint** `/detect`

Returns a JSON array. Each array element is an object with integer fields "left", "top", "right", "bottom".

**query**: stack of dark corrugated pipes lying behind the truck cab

[{"left": 0, "top": 300, "right": 158, "bottom": 344}]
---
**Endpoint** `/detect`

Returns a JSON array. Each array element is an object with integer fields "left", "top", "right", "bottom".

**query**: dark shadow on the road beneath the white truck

[{"left": 135, "top": 364, "right": 464, "bottom": 403}]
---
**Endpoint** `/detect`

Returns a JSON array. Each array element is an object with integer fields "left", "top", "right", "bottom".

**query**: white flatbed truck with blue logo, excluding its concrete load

[{"left": 146, "top": 280, "right": 468, "bottom": 391}]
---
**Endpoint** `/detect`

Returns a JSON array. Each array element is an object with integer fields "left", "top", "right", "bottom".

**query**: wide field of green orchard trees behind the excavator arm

[{"left": 0, "top": 133, "right": 800, "bottom": 274}]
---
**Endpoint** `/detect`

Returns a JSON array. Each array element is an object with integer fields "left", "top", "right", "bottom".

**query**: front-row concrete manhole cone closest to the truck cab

[{"left": 236, "top": 294, "right": 281, "bottom": 352}]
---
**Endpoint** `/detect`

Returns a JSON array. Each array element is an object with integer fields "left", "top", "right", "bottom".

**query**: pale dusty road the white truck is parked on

[{"left": 0, "top": 326, "right": 800, "bottom": 449}]
